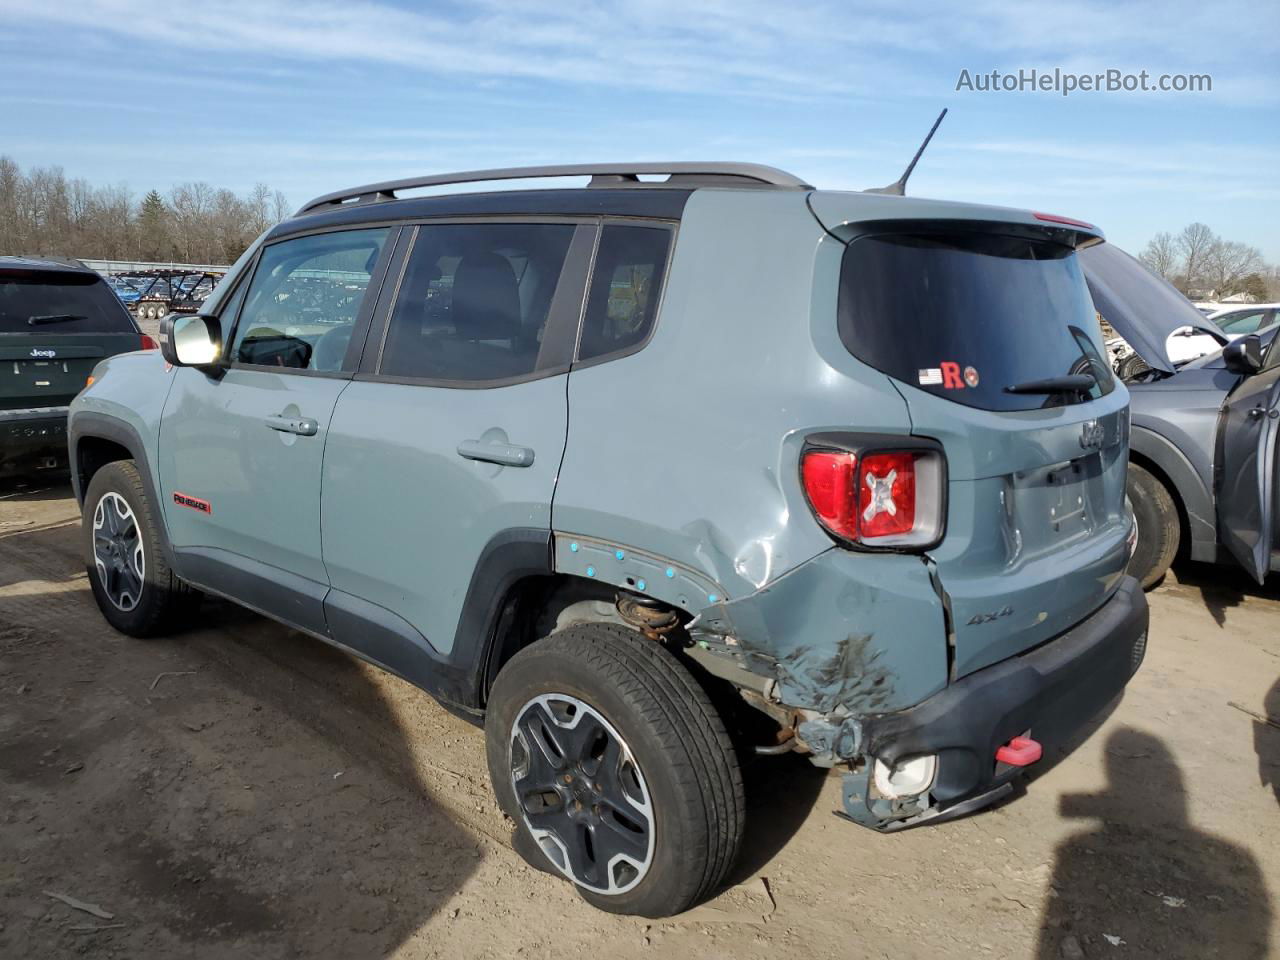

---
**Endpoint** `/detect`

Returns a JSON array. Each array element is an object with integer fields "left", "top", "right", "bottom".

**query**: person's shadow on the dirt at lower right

[{"left": 1036, "top": 727, "right": 1271, "bottom": 960}]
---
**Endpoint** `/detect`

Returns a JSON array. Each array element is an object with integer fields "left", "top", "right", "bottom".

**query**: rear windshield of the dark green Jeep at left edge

[{"left": 0, "top": 270, "right": 134, "bottom": 337}]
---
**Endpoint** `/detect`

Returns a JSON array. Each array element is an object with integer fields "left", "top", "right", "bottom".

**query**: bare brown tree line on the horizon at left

[{"left": 0, "top": 156, "right": 292, "bottom": 264}]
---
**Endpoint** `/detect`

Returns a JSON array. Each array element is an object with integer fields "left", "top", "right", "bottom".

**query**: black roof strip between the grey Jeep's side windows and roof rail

[{"left": 269, "top": 187, "right": 692, "bottom": 239}]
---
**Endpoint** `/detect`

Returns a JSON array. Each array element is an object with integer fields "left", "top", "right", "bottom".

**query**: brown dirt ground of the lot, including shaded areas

[{"left": 0, "top": 481, "right": 1280, "bottom": 960}]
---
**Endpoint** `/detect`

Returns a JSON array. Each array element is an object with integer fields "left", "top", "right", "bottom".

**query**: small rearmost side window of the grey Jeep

[{"left": 577, "top": 224, "right": 671, "bottom": 361}]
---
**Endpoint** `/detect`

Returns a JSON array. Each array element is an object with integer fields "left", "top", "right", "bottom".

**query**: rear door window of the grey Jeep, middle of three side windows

[{"left": 379, "top": 223, "right": 576, "bottom": 383}]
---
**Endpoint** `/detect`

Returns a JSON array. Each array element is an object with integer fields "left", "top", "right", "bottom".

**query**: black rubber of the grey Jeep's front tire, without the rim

[{"left": 81, "top": 460, "right": 201, "bottom": 637}]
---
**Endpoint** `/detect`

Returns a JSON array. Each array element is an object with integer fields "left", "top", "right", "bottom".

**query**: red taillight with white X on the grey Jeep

[{"left": 800, "top": 448, "right": 946, "bottom": 548}]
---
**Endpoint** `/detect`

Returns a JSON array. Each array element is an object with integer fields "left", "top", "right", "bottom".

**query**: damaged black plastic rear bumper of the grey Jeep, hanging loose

[{"left": 844, "top": 577, "right": 1148, "bottom": 831}]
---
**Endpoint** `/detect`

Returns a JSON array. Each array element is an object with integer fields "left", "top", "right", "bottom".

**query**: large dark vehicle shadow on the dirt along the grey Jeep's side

[{"left": 0, "top": 527, "right": 484, "bottom": 957}]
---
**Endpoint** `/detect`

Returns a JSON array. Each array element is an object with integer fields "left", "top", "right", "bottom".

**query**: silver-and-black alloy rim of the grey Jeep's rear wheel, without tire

[{"left": 511, "top": 694, "right": 654, "bottom": 896}]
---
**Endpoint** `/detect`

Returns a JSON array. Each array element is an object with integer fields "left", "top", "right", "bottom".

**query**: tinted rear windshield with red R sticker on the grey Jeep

[{"left": 840, "top": 233, "right": 1115, "bottom": 410}]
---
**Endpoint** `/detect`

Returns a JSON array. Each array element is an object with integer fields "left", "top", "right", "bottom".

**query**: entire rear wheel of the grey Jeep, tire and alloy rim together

[{"left": 485, "top": 623, "right": 745, "bottom": 916}]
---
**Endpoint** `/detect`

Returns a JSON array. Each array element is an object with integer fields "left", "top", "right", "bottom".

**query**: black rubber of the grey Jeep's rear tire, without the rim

[{"left": 485, "top": 623, "right": 745, "bottom": 916}]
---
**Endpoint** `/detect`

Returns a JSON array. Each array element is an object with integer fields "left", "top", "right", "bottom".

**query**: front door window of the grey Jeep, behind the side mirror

[{"left": 230, "top": 228, "right": 388, "bottom": 372}]
